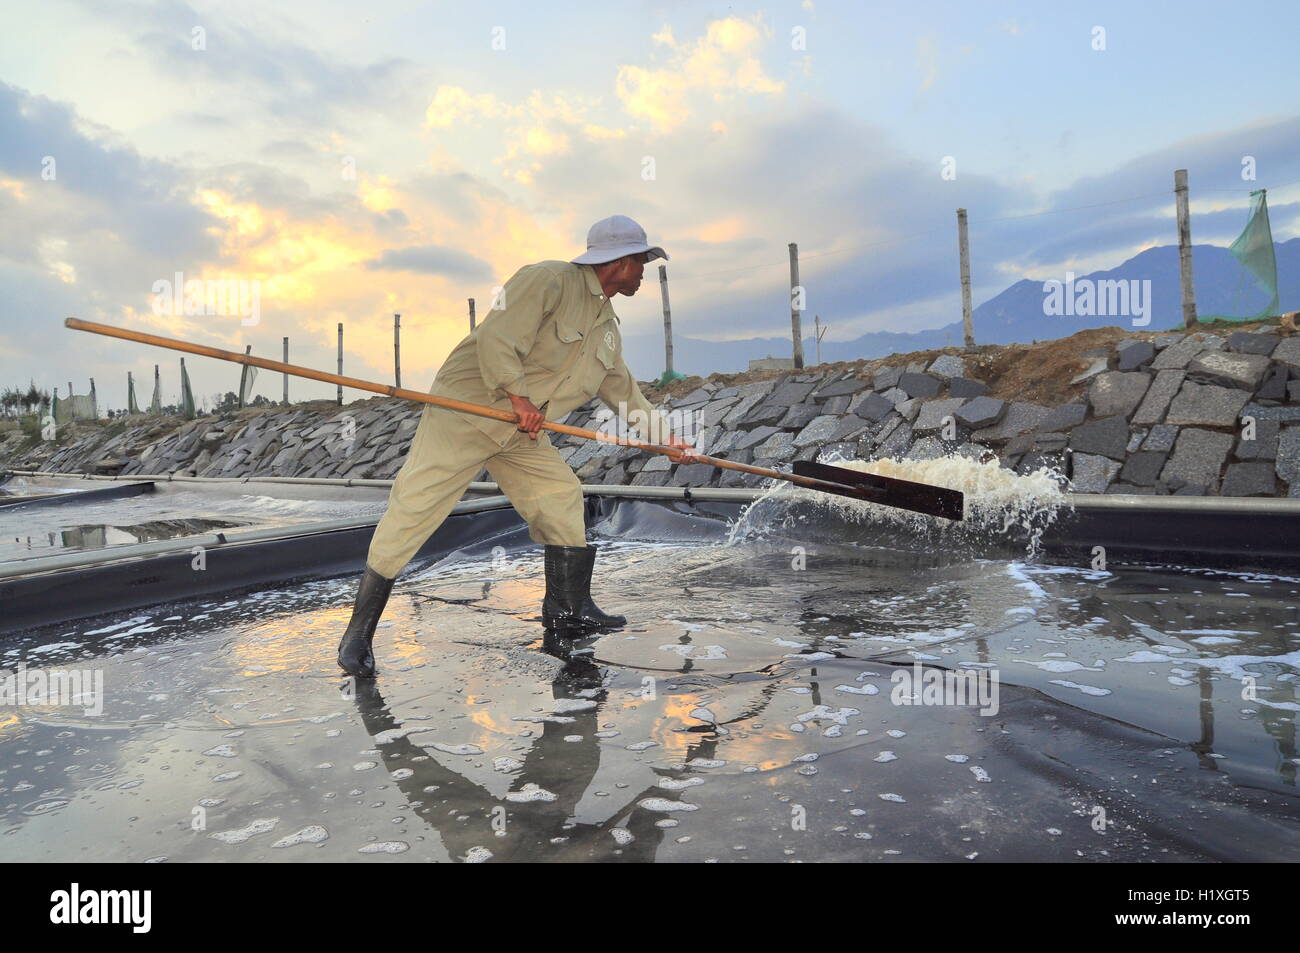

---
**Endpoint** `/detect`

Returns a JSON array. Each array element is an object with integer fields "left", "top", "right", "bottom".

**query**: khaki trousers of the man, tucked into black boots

[{"left": 365, "top": 406, "right": 586, "bottom": 579}]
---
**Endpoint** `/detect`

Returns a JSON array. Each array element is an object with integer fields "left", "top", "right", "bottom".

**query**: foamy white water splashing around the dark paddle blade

[{"left": 727, "top": 455, "right": 1069, "bottom": 556}]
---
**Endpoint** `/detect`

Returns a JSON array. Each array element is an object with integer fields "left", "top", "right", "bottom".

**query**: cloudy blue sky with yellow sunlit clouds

[{"left": 0, "top": 0, "right": 1300, "bottom": 407}]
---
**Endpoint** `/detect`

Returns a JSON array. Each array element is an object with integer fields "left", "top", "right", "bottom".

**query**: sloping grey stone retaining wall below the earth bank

[{"left": 0, "top": 332, "right": 1300, "bottom": 497}]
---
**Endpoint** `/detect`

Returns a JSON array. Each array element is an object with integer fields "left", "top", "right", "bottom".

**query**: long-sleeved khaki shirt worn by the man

[{"left": 429, "top": 261, "right": 672, "bottom": 446}]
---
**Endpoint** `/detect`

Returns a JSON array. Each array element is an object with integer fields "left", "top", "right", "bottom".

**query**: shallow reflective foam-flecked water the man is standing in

[{"left": 0, "top": 501, "right": 1300, "bottom": 862}]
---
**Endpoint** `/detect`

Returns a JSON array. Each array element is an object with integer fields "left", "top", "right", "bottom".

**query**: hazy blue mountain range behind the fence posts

[{"left": 624, "top": 238, "right": 1300, "bottom": 380}]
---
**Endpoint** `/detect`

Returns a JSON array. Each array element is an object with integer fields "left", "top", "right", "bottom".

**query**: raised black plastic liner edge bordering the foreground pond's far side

[{"left": 0, "top": 488, "right": 1300, "bottom": 634}]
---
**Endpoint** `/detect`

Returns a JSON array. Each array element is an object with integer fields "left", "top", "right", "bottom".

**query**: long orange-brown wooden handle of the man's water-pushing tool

[{"left": 64, "top": 317, "right": 867, "bottom": 495}]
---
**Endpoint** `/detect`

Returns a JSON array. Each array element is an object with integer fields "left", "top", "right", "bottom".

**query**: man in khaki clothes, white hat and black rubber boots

[{"left": 338, "top": 215, "right": 692, "bottom": 677}]
